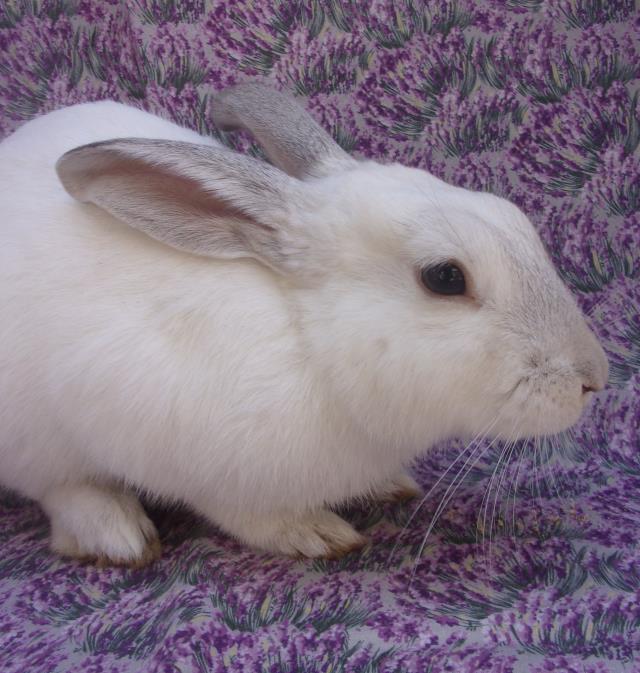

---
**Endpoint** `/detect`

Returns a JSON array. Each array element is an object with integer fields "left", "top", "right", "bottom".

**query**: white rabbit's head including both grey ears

[{"left": 58, "top": 82, "right": 607, "bottom": 449}]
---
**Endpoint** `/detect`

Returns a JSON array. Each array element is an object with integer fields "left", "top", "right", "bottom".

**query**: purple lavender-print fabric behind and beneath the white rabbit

[{"left": 0, "top": 0, "right": 640, "bottom": 673}]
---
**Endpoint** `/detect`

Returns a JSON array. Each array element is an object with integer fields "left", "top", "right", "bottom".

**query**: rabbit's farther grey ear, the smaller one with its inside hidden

[{"left": 213, "top": 80, "right": 357, "bottom": 179}]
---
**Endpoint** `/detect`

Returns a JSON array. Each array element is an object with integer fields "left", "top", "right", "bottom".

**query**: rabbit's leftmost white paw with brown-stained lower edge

[{"left": 42, "top": 484, "right": 160, "bottom": 568}]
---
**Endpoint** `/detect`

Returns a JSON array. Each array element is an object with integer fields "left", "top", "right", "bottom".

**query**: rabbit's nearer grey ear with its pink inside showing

[{"left": 56, "top": 139, "right": 320, "bottom": 272}]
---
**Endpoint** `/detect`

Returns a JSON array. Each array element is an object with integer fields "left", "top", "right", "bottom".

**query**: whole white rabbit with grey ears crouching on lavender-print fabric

[{"left": 0, "top": 80, "right": 607, "bottom": 567}]
